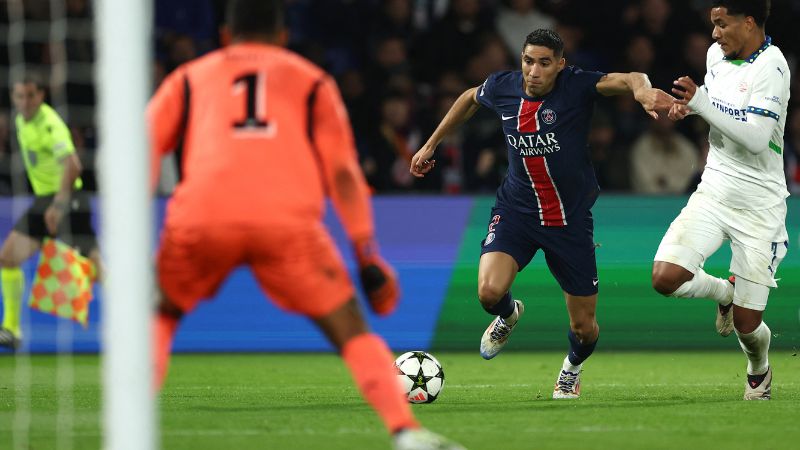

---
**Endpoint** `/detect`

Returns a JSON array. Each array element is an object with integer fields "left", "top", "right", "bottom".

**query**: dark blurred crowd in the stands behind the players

[{"left": 0, "top": 0, "right": 800, "bottom": 195}]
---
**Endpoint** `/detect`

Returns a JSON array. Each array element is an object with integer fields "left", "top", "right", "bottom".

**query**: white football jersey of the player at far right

[{"left": 697, "top": 37, "right": 790, "bottom": 210}]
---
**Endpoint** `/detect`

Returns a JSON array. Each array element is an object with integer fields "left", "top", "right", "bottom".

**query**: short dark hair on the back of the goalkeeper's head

[{"left": 226, "top": 0, "right": 283, "bottom": 36}]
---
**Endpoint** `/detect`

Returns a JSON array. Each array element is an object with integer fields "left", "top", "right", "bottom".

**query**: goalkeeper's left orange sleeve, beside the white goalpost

[{"left": 146, "top": 68, "right": 188, "bottom": 191}]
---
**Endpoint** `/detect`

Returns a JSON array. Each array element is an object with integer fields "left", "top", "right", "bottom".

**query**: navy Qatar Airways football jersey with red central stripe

[{"left": 476, "top": 66, "right": 605, "bottom": 227}]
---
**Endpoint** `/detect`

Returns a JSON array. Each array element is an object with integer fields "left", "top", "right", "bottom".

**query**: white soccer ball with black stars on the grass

[{"left": 394, "top": 351, "right": 444, "bottom": 403}]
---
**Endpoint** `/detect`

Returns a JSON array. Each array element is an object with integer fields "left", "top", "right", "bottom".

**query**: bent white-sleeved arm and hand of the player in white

[{"left": 672, "top": 76, "right": 778, "bottom": 154}]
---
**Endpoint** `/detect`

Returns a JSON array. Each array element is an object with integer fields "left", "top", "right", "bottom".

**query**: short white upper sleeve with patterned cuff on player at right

[{"left": 747, "top": 55, "right": 790, "bottom": 120}]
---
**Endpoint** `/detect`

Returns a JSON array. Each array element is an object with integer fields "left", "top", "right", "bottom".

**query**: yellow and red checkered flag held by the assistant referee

[{"left": 28, "top": 238, "right": 93, "bottom": 328}]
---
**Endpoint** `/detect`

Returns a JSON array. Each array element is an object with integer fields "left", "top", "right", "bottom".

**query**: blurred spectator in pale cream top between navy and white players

[{"left": 631, "top": 116, "right": 698, "bottom": 194}]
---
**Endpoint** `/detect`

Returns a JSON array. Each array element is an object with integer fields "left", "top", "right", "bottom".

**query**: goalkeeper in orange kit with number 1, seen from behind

[{"left": 147, "top": 0, "right": 461, "bottom": 449}]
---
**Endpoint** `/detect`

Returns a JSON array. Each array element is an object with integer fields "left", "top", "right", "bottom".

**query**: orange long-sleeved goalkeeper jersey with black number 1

[{"left": 147, "top": 43, "right": 373, "bottom": 238}]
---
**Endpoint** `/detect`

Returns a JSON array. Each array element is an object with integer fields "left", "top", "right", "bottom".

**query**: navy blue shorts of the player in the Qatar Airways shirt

[{"left": 481, "top": 207, "right": 598, "bottom": 296}]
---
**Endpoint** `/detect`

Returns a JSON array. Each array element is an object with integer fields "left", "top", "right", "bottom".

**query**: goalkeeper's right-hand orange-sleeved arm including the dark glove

[{"left": 311, "top": 77, "right": 400, "bottom": 315}]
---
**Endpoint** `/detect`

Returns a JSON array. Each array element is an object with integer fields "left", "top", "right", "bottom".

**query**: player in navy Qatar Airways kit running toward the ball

[{"left": 410, "top": 30, "right": 673, "bottom": 398}]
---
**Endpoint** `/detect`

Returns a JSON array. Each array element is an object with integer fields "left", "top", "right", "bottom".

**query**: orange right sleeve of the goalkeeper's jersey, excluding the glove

[{"left": 309, "top": 76, "right": 374, "bottom": 241}]
